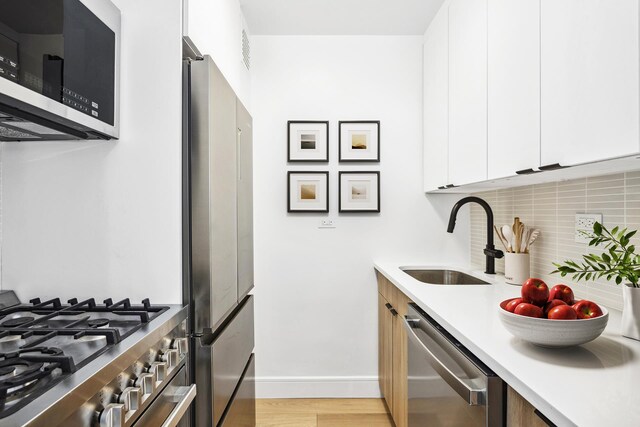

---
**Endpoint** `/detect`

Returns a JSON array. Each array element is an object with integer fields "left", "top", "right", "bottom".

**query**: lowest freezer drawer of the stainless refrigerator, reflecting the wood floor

[{"left": 221, "top": 356, "right": 256, "bottom": 427}]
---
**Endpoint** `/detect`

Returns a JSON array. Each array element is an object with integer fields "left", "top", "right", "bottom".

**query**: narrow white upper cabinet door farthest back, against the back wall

[{"left": 423, "top": 6, "right": 449, "bottom": 191}]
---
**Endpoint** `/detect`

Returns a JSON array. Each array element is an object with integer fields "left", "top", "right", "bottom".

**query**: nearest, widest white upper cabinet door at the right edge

[{"left": 540, "top": 0, "right": 640, "bottom": 166}]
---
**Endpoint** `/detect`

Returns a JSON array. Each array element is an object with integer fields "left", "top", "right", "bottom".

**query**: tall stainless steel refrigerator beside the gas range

[{"left": 183, "top": 46, "right": 255, "bottom": 427}]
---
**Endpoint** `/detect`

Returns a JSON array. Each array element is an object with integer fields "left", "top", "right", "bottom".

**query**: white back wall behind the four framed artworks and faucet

[{"left": 251, "top": 36, "right": 469, "bottom": 397}]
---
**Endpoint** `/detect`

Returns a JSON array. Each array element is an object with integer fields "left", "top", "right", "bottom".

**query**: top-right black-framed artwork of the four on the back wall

[{"left": 338, "top": 121, "right": 380, "bottom": 162}]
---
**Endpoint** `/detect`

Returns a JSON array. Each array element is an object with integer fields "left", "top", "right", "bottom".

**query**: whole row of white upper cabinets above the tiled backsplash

[{"left": 424, "top": 0, "right": 640, "bottom": 191}]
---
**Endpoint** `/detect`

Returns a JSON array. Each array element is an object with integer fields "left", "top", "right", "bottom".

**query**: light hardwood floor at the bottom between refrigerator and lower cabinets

[{"left": 256, "top": 399, "right": 394, "bottom": 427}]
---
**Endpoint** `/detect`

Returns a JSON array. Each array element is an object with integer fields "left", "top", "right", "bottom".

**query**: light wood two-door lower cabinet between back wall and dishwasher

[{"left": 378, "top": 273, "right": 410, "bottom": 427}]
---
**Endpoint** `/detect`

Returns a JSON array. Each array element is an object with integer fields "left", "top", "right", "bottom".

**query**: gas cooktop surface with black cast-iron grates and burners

[{"left": 0, "top": 298, "right": 169, "bottom": 419}]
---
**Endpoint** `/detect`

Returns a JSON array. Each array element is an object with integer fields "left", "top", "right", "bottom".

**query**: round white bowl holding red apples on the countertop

[{"left": 499, "top": 298, "right": 609, "bottom": 348}]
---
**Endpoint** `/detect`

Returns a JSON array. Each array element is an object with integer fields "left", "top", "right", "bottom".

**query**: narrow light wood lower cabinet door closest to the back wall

[{"left": 378, "top": 294, "right": 393, "bottom": 410}]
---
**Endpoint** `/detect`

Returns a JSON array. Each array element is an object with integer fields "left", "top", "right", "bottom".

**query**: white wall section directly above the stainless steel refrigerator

[{"left": 183, "top": 0, "right": 251, "bottom": 112}]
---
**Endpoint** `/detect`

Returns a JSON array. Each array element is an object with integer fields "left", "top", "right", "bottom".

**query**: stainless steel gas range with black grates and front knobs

[{"left": 0, "top": 292, "right": 195, "bottom": 427}]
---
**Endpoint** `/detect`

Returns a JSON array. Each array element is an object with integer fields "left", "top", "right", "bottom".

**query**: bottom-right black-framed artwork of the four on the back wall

[{"left": 338, "top": 171, "right": 380, "bottom": 212}]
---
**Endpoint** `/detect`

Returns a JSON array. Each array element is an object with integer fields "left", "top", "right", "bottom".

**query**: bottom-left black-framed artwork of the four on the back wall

[{"left": 287, "top": 172, "right": 329, "bottom": 212}]
